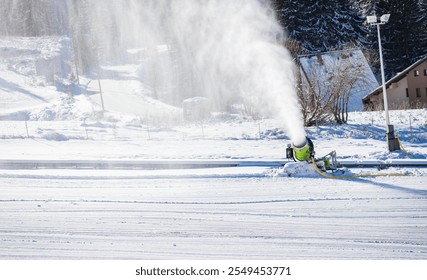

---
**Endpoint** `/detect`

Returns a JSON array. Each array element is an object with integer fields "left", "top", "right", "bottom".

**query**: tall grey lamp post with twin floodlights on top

[{"left": 367, "top": 14, "right": 400, "bottom": 152}]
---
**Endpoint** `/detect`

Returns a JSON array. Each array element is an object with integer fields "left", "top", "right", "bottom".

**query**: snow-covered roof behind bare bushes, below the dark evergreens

[{"left": 299, "top": 49, "right": 378, "bottom": 111}]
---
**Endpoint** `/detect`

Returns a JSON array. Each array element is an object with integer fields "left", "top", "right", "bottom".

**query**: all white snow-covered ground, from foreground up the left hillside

[{"left": 0, "top": 36, "right": 427, "bottom": 259}]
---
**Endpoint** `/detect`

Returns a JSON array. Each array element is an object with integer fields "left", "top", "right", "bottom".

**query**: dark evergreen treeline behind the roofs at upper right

[{"left": 272, "top": 0, "right": 427, "bottom": 78}]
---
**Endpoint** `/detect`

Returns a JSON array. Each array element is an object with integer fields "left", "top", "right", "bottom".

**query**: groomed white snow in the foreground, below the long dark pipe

[{"left": 0, "top": 171, "right": 427, "bottom": 259}]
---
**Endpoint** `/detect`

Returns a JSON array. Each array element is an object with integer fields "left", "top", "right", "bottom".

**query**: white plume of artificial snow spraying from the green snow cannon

[{"left": 70, "top": 0, "right": 305, "bottom": 145}]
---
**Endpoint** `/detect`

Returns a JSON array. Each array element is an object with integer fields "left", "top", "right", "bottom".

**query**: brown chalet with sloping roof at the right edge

[{"left": 363, "top": 56, "right": 427, "bottom": 110}]
